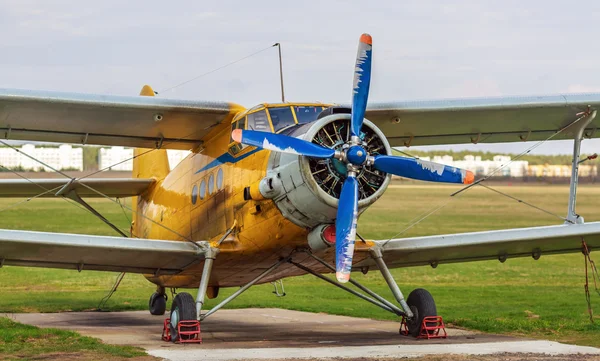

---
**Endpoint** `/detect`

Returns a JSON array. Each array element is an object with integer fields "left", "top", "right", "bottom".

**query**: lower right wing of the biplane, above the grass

[{"left": 355, "top": 222, "right": 600, "bottom": 267}]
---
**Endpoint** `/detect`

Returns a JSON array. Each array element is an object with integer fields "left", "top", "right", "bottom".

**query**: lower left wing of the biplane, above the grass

[{"left": 0, "top": 229, "right": 204, "bottom": 275}]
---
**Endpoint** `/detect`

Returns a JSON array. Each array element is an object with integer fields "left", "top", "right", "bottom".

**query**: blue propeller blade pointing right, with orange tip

[{"left": 373, "top": 155, "right": 475, "bottom": 184}]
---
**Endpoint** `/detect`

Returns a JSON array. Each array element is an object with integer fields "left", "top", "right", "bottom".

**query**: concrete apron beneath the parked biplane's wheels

[{"left": 5, "top": 308, "right": 600, "bottom": 360}]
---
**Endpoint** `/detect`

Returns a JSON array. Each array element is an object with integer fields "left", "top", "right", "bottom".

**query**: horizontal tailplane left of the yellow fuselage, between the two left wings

[{"left": 0, "top": 178, "right": 155, "bottom": 198}]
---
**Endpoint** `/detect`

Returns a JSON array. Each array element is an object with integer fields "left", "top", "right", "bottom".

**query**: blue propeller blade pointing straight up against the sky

[{"left": 351, "top": 34, "right": 373, "bottom": 137}]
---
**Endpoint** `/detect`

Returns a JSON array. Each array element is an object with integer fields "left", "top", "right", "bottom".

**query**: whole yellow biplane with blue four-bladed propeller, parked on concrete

[{"left": 0, "top": 34, "right": 600, "bottom": 338}]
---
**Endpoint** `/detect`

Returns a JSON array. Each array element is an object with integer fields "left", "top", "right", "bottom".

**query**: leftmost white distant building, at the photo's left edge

[{"left": 0, "top": 144, "right": 83, "bottom": 171}]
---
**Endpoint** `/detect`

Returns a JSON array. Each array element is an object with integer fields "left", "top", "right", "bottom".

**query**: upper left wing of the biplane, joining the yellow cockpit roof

[{"left": 0, "top": 89, "right": 243, "bottom": 150}]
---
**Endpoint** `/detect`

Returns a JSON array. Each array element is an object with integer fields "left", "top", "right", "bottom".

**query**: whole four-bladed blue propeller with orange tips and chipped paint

[{"left": 231, "top": 34, "right": 474, "bottom": 283}]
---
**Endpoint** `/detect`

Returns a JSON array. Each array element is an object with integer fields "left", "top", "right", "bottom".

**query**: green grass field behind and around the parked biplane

[{"left": 0, "top": 184, "right": 600, "bottom": 351}]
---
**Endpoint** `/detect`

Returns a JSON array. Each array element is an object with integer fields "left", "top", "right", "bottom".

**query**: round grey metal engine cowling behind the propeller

[{"left": 266, "top": 114, "right": 391, "bottom": 228}]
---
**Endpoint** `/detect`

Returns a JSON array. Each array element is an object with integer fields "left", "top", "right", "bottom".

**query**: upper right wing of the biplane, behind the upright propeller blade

[{"left": 365, "top": 94, "right": 600, "bottom": 146}]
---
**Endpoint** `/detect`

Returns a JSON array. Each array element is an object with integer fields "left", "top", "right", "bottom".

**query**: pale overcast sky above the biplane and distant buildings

[{"left": 0, "top": 0, "right": 600, "bottom": 154}]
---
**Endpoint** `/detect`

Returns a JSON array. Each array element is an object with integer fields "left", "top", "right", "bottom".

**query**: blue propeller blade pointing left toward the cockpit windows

[{"left": 231, "top": 129, "right": 335, "bottom": 158}]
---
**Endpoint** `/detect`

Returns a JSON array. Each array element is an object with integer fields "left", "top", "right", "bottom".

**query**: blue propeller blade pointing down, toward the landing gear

[{"left": 335, "top": 175, "right": 358, "bottom": 283}]
